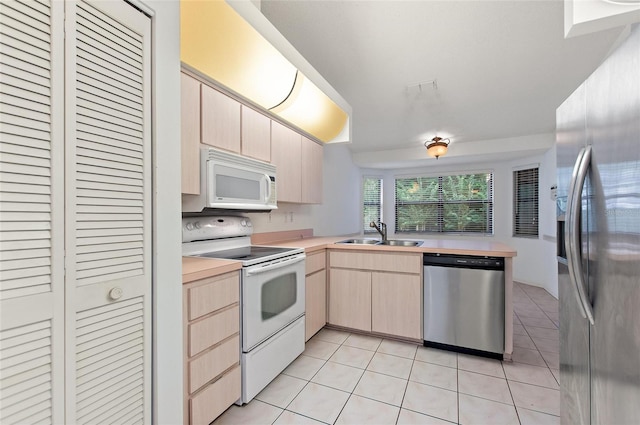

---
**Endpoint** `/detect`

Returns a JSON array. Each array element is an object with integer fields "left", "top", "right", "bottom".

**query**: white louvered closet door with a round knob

[{"left": 65, "top": 1, "right": 151, "bottom": 424}]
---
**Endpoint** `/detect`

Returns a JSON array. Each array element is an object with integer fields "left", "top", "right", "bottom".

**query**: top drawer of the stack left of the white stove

[{"left": 187, "top": 272, "right": 240, "bottom": 320}]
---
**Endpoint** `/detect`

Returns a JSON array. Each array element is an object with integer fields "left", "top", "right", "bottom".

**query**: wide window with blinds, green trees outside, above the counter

[{"left": 395, "top": 173, "right": 493, "bottom": 234}]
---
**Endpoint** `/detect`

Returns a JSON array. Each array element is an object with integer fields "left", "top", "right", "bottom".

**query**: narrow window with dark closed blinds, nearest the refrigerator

[{"left": 513, "top": 168, "right": 538, "bottom": 238}]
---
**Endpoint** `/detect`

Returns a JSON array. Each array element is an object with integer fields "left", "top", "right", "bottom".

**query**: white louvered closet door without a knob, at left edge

[{"left": 0, "top": 0, "right": 64, "bottom": 424}]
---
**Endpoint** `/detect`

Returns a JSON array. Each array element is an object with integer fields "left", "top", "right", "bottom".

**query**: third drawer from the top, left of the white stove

[{"left": 189, "top": 335, "right": 240, "bottom": 393}]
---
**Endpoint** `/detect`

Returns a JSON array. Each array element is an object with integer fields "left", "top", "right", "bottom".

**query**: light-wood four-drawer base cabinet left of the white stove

[{"left": 182, "top": 272, "right": 241, "bottom": 425}]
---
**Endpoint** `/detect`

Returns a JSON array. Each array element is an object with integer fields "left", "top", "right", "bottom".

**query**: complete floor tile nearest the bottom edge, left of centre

[{"left": 288, "top": 382, "right": 349, "bottom": 423}]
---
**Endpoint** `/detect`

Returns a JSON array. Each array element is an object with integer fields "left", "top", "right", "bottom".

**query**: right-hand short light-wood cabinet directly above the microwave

[{"left": 241, "top": 105, "right": 271, "bottom": 162}]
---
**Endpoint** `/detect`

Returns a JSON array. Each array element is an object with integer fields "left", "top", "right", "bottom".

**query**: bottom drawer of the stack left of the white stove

[{"left": 189, "top": 366, "right": 240, "bottom": 425}]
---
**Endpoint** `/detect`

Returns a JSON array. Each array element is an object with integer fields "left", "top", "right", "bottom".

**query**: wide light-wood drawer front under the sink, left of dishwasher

[{"left": 329, "top": 251, "right": 422, "bottom": 274}]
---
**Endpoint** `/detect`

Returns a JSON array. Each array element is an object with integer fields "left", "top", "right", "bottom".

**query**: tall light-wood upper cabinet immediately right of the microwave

[{"left": 271, "top": 121, "right": 302, "bottom": 203}]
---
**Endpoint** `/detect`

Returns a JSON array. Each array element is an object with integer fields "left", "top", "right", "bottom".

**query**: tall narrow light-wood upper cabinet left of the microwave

[{"left": 180, "top": 73, "right": 200, "bottom": 195}]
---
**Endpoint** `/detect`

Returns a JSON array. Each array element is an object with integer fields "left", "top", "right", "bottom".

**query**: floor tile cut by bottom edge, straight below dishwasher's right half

[{"left": 459, "top": 394, "right": 518, "bottom": 425}]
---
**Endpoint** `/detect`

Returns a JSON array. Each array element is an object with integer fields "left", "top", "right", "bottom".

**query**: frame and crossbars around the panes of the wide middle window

[{"left": 393, "top": 170, "right": 495, "bottom": 237}]
